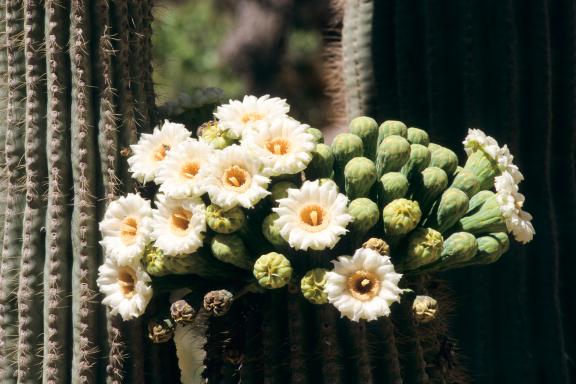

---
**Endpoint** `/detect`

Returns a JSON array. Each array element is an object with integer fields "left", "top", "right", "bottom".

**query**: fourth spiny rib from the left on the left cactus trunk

[{"left": 70, "top": 0, "right": 99, "bottom": 383}]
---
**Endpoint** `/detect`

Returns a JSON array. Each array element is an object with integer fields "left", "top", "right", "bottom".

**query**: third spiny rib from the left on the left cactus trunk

[{"left": 43, "top": 0, "right": 71, "bottom": 384}]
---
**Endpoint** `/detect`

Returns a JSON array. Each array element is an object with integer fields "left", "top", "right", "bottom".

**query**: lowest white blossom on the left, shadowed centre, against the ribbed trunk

[{"left": 96, "top": 258, "right": 153, "bottom": 320}]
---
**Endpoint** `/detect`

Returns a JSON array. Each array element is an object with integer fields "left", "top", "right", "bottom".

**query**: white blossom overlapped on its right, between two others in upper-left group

[{"left": 156, "top": 139, "right": 214, "bottom": 199}]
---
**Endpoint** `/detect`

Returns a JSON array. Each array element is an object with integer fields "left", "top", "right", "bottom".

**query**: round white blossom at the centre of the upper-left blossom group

[{"left": 201, "top": 145, "right": 270, "bottom": 210}]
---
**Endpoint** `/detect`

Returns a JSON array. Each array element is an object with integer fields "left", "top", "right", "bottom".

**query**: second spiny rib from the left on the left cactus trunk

[{"left": 16, "top": 1, "right": 47, "bottom": 383}]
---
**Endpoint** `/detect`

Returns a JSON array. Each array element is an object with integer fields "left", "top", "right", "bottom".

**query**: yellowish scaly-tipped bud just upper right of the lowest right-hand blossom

[{"left": 400, "top": 228, "right": 444, "bottom": 271}]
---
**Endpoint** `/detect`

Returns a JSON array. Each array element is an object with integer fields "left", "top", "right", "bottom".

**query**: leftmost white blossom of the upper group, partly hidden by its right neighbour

[{"left": 128, "top": 120, "right": 190, "bottom": 183}]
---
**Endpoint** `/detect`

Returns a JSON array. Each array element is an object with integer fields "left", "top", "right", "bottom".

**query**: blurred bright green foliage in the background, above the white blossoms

[{"left": 153, "top": 0, "right": 243, "bottom": 104}]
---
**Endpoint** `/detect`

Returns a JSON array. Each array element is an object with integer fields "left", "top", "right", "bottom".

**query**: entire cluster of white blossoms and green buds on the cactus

[{"left": 98, "top": 96, "right": 534, "bottom": 330}]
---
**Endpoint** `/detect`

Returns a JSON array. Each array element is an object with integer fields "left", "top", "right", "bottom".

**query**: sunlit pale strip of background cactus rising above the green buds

[{"left": 342, "top": 0, "right": 375, "bottom": 121}]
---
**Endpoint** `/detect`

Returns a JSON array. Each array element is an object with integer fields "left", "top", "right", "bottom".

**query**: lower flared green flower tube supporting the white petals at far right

[{"left": 459, "top": 191, "right": 506, "bottom": 235}]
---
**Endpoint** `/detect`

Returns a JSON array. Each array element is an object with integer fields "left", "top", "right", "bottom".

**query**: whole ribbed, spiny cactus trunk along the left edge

[{"left": 0, "top": 0, "right": 155, "bottom": 383}]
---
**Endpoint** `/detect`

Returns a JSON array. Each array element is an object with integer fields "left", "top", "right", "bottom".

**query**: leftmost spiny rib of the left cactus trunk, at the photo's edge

[{"left": 0, "top": 0, "right": 26, "bottom": 383}]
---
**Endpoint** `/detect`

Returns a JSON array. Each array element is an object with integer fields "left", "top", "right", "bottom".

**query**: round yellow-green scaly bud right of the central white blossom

[{"left": 382, "top": 199, "right": 422, "bottom": 236}]
